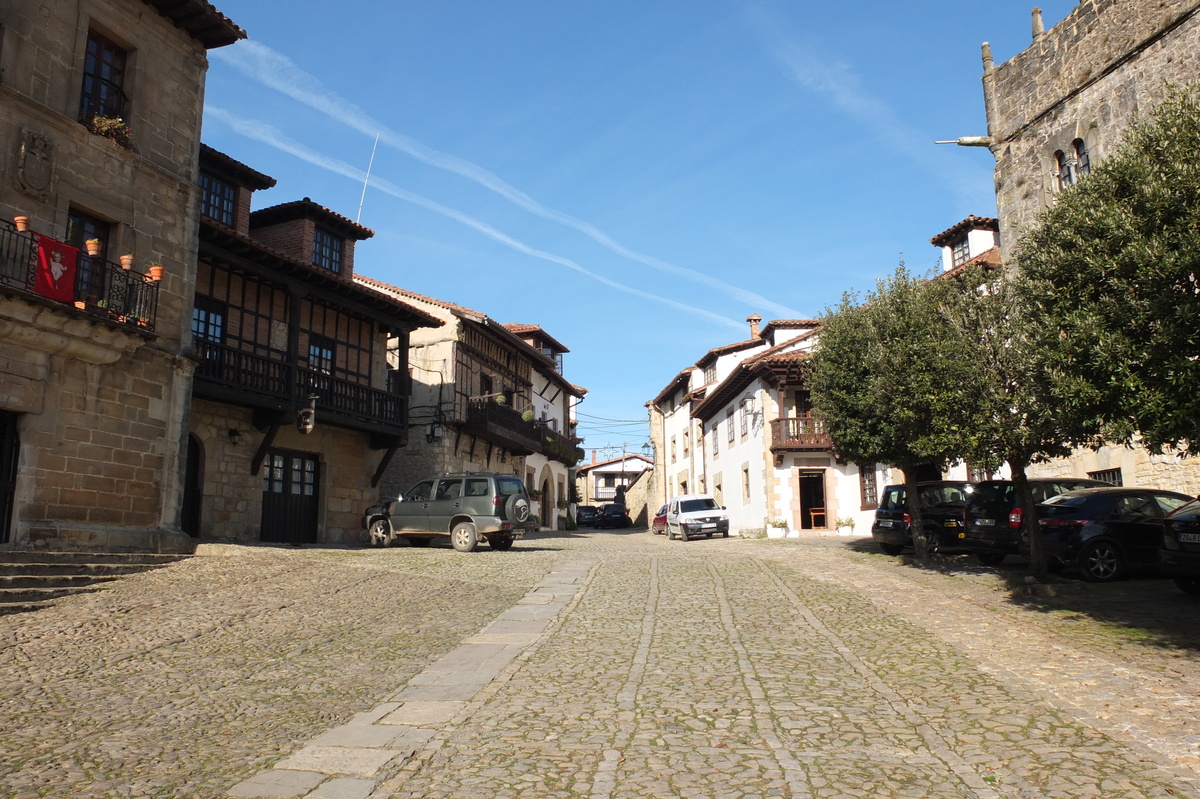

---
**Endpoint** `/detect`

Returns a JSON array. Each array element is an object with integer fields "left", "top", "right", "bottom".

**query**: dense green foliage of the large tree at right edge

[{"left": 1018, "top": 86, "right": 1200, "bottom": 452}]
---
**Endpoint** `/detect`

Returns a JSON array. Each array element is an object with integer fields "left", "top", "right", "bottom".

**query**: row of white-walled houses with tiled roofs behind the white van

[{"left": 648, "top": 316, "right": 889, "bottom": 533}]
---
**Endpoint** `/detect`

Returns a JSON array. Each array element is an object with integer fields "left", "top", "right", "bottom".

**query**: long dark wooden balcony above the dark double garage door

[{"left": 194, "top": 340, "right": 408, "bottom": 435}]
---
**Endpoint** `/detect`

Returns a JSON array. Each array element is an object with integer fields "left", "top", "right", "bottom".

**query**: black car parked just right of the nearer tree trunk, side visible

[{"left": 1019, "top": 487, "right": 1192, "bottom": 583}]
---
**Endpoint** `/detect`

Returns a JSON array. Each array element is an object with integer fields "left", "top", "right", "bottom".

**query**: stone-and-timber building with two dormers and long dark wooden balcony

[{"left": 184, "top": 148, "right": 442, "bottom": 545}]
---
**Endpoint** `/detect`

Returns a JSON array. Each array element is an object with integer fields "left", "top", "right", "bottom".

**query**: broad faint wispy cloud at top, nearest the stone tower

[{"left": 744, "top": 2, "right": 991, "bottom": 203}]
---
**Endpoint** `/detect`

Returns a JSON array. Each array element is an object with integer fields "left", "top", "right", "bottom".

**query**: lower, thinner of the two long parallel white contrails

[{"left": 204, "top": 104, "right": 745, "bottom": 331}]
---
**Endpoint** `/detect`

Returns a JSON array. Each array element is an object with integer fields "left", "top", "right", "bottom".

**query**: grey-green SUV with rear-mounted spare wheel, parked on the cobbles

[{"left": 362, "top": 471, "right": 530, "bottom": 552}]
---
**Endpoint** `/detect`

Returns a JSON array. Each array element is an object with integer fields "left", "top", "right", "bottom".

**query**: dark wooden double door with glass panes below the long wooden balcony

[{"left": 259, "top": 451, "right": 320, "bottom": 543}]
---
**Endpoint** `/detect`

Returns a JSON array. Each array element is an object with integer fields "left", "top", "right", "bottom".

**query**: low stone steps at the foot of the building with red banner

[{"left": 0, "top": 552, "right": 186, "bottom": 615}]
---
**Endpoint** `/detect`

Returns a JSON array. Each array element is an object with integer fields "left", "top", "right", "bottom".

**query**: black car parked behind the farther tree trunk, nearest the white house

[{"left": 871, "top": 480, "right": 974, "bottom": 554}]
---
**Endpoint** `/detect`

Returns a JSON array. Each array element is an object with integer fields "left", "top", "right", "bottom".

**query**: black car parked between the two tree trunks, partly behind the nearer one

[{"left": 962, "top": 477, "right": 1111, "bottom": 566}]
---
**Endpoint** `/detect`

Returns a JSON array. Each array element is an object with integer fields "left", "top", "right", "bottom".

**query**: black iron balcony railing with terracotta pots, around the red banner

[{"left": 0, "top": 222, "right": 158, "bottom": 332}]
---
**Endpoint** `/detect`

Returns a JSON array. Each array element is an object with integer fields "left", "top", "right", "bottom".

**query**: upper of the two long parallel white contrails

[{"left": 211, "top": 41, "right": 802, "bottom": 318}]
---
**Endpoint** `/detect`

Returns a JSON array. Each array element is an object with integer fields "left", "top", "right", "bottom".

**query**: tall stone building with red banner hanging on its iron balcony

[{"left": 0, "top": 0, "right": 245, "bottom": 551}]
